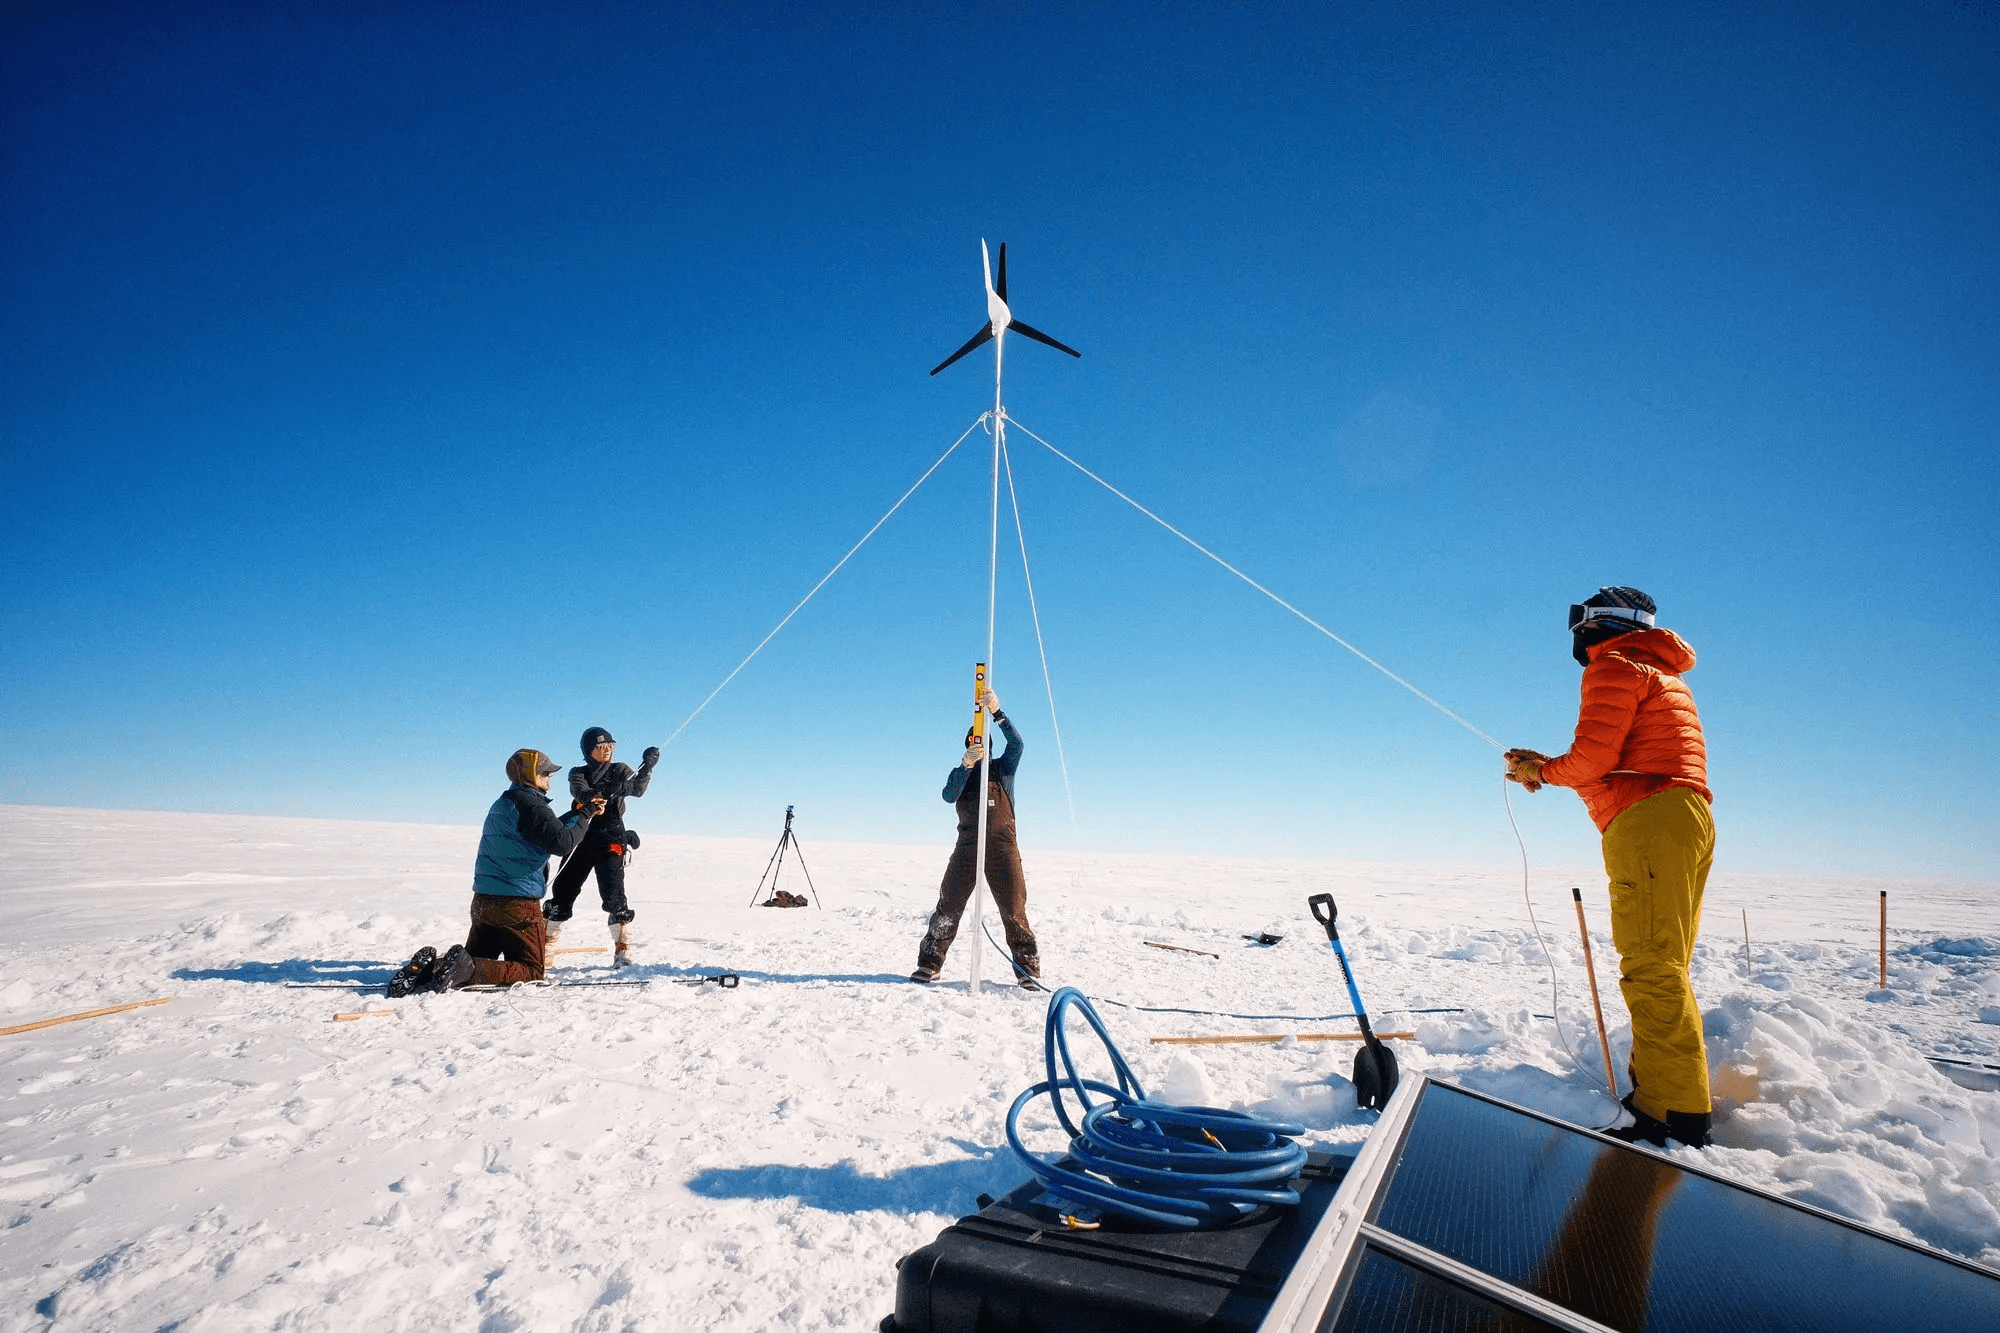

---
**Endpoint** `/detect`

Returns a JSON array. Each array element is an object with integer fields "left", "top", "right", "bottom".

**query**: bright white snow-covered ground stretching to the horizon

[{"left": 0, "top": 807, "right": 2000, "bottom": 1333}]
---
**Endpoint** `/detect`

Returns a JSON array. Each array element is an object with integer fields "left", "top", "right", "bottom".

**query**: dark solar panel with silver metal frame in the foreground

[{"left": 1262, "top": 1079, "right": 2000, "bottom": 1333}]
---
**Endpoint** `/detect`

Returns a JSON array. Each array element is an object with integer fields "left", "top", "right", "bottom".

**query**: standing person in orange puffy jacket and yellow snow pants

[{"left": 1506, "top": 586, "right": 1716, "bottom": 1147}]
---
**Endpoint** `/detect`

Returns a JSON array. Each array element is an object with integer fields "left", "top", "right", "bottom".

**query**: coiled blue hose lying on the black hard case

[{"left": 1006, "top": 987, "right": 1306, "bottom": 1231}]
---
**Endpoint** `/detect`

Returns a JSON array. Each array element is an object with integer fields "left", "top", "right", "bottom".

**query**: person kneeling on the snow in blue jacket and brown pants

[{"left": 388, "top": 751, "right": 604, "bottom": 995}]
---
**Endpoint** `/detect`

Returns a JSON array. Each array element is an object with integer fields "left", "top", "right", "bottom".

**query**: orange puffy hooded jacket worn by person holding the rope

[{"left": 1542, "top": 628, "right": 1714, "bottom": 833}]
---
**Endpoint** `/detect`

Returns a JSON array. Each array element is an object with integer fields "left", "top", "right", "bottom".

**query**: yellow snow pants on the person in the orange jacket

[{"left": 1604, "top": 787, "right": 1716, "bottom": 1121}]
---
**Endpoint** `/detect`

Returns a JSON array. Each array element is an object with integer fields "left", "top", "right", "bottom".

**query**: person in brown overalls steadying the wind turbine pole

[{"left": 910, "top": 689, "right": 1042, "bottom": 989}]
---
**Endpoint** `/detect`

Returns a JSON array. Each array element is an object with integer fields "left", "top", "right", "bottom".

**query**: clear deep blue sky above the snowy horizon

[{"left": 0, "top": 0, "right": 2000, "bottom": 879}]
